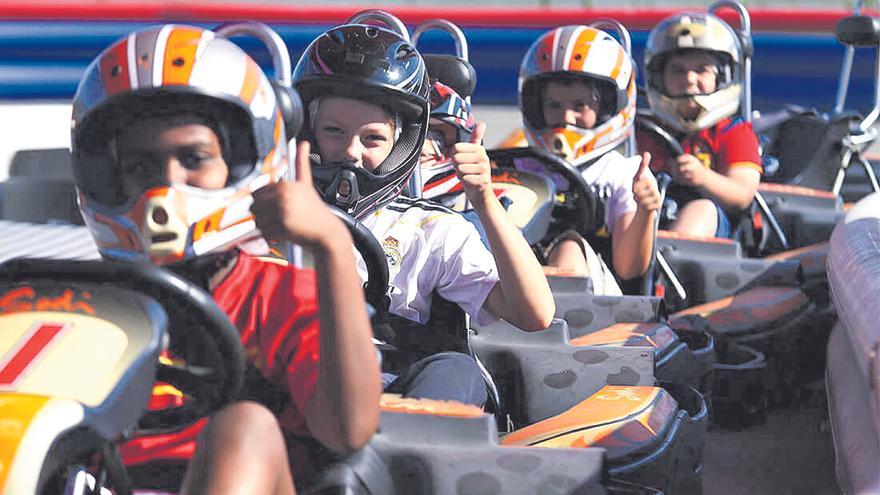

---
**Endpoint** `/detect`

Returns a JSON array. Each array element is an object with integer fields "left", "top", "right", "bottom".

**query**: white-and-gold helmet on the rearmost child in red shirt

[{"left": 645, "top": 12, "right": 743, "bottom": 132}]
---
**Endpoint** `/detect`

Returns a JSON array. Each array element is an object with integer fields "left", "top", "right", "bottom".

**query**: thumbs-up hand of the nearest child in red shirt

[{"left": 251, "top": 141, "right": 345, "bottom": 248}]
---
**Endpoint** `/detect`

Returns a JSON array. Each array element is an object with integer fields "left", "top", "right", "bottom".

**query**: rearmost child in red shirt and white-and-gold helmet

[{"left": 638, "top": 13, "right": 762, "bottom": 237}]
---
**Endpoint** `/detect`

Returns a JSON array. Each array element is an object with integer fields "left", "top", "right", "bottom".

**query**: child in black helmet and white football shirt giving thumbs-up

[{"left": 293, "top": 25, "right": 555, "bottom": 405}]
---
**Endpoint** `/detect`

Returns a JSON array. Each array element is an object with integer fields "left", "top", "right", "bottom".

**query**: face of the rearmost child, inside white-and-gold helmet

[{"left": 663, "top": 51, "right": 718, "bottom": 118}]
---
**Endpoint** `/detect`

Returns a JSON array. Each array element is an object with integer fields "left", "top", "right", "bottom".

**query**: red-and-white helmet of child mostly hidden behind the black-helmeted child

[{"left": 421, "top": 81, "right": 477, "bottom": 199}]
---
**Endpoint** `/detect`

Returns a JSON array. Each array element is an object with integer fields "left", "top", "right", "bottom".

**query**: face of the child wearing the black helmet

[{"left": 314, "top": 96, "right": 394, "bottom": 172}]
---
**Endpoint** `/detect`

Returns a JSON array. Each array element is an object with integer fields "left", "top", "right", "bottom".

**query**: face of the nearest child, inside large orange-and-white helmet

[{"left": 116, "top": 118, "right": 229, "bottom": 196}]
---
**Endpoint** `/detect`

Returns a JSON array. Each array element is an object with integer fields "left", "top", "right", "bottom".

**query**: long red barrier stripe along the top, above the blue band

[{"left": 0, "top": 0, "right": 876, "bottom": 32}]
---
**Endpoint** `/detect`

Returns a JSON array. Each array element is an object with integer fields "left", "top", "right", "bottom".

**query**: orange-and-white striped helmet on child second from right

[{"left": 519, "top": 26, "right": 636, "bottom": 166}]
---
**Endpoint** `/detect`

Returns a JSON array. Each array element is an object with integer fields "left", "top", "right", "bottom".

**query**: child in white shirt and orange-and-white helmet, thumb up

[{"left": 520, "top": 26, "right": 660, "bottom": 294}]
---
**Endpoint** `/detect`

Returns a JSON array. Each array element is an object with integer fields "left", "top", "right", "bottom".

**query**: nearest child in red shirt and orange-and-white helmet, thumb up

[{"left": 72, "top": 26, "right": 381, "bottom": 494}]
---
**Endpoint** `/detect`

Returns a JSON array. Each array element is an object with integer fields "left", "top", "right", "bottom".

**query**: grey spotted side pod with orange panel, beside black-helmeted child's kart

[{"left": 470, "top": 320, "right": 708, "bottom": 490}]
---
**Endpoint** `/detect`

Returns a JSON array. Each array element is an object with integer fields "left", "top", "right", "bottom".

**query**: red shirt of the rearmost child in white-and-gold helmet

[{"left": 636, "top": 117, "right": 763, "bottom": 175}]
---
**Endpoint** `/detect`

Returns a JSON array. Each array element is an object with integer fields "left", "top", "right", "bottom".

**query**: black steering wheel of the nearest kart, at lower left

[{"left": 0, "top": 259, "right": 245, "bottom": 430}]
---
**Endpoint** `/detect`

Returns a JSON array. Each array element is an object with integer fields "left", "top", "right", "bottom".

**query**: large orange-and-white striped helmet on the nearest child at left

[{"left": 71, "top": 25, "right": 295, "bottom": 264}]
